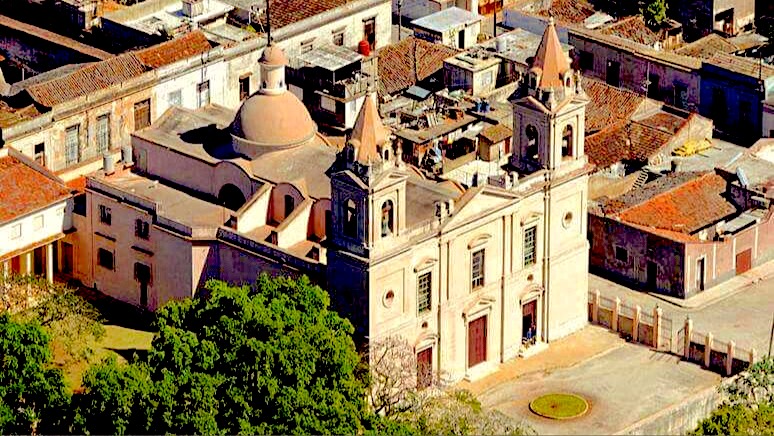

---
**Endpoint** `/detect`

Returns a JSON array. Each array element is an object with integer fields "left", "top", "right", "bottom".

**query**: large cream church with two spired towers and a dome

[{"left": 66, "top": 22, "right": 590, "bottom": 380}]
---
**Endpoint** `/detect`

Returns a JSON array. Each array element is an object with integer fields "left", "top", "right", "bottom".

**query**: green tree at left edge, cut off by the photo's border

[{"left": 0, "top": 314, "right": 69, "bottom": 434}]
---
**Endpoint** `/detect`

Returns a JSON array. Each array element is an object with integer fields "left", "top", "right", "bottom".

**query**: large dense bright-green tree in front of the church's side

[{"left": 76, "top": 275, "right": 367, "bottom": 434}]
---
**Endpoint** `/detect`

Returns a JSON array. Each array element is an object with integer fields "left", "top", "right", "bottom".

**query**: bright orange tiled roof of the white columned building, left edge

[{"left": 0, "top": 155, "right": 70, "bottom": 222}]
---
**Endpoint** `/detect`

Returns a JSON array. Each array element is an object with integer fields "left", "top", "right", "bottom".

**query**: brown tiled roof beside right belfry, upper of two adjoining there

[{"left": 581, "top": 77, "right": 645, "bottom": 134}]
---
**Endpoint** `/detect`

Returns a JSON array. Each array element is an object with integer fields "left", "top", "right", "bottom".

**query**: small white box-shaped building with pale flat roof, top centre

[{"left": 411, "top": 7, "right": 484, "bottom": 50}]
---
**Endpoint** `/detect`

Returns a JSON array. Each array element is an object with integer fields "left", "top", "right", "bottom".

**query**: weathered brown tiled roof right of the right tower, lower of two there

[{"left": 585, "top": 118, "right": 672, "bottom": 169}]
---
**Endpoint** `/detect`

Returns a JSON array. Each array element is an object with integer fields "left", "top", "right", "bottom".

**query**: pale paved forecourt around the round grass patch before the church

[{"left": 470, "top": 326, "right": 721, "bottom": 434}]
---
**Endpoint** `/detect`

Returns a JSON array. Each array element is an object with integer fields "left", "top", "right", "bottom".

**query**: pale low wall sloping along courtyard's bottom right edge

[{"left": 616, "top": 377, "right": 736, "bottom": 435}]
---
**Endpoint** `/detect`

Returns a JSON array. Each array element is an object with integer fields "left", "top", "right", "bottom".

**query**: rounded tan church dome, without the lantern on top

[{"left": 231, "top": 92, "right": 317, "bottom": 156}]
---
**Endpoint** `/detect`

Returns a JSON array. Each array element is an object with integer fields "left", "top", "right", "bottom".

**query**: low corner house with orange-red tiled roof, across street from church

[{"left": 589, "top": 167, "right": 774, "bottom": 298}]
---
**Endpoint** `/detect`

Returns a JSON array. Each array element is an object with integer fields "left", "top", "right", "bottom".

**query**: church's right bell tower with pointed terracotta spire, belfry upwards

[{"left": 511, "top": 17, "right": 588, "bottom": 172}]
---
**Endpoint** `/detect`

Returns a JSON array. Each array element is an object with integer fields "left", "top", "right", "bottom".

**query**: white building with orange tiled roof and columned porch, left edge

[{"left": 0, "top": 147, "right": 72, "bottom": 286}]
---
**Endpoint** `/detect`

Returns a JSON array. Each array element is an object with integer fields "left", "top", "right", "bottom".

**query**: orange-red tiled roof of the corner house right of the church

[{"left": 619, "top": 173, "right": 737, "bottom": 234}]
